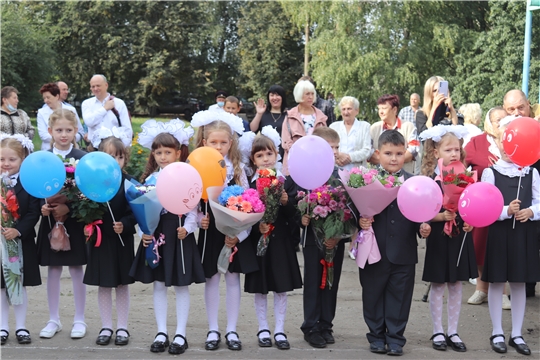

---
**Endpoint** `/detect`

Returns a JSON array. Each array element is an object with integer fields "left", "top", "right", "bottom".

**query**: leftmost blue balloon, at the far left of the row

[{"left": 19, "top": 151, "right": 66, "bottom": 199}]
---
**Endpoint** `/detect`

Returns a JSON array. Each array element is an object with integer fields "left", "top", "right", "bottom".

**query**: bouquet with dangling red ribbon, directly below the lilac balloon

[{"left": 297, "top": 185, "right": 353, "bottom": 289}]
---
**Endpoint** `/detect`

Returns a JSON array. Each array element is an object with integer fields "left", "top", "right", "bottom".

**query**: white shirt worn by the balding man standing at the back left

[{"left": 82, "top": 93, "right": 133, "bottom": 139}]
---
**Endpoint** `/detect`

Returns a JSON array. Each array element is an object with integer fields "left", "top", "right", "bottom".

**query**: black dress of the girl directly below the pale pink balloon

[{"left": 129, "top": 212, "right": 205, "bottom": 286}]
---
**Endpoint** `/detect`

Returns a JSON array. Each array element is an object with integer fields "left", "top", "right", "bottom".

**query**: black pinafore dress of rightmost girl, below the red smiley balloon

[{"left": 482, "top": 167, "right": 540, "bottom": 283}]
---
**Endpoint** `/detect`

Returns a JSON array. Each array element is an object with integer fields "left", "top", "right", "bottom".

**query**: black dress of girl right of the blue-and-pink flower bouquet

[{"left": 244, "top": 176, "right": 302, "bottom": 294}]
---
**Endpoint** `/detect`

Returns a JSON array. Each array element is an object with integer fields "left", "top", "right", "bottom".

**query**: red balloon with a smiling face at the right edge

[{"left": 502, "top": 117, "right": 540, "bottom": 166}]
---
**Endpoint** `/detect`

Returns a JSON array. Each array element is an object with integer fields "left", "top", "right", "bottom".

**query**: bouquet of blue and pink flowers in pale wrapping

[{"left": 207, "top": 185, "right": 265, "bottom": 273}]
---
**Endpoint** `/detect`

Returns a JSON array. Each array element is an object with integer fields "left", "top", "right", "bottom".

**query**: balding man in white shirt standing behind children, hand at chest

[{"left": 82, "top": 74, "right": 133, "bottom": 145}]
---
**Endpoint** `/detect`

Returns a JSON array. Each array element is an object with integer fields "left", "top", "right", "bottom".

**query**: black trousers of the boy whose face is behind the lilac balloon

[{"left": 300, "top": 241, "right": 345, "bottom": 334}]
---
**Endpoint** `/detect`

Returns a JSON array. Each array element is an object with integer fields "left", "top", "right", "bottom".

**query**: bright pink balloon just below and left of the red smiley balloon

[{"left": 458, "top": 182, "right": 504, "bottom": 227}]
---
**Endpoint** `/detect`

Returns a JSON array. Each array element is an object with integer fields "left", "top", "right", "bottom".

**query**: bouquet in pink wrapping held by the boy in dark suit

[{"left": 339, "top": 167, "right": 403, "bottom": 269}]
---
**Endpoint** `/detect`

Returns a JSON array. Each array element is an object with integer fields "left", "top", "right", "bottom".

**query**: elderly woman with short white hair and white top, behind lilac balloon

[{"left": 330, "top": 96, "right": 371, "bottom": 170}]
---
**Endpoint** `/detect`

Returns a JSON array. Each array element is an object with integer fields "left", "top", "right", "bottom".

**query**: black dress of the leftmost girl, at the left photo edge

[{"left": 1, "top": 179, "right": 41, "bottom": 289}]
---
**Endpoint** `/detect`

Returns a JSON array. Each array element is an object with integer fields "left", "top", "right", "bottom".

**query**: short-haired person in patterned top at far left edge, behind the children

[{"left": 0, "top": 86, "right": 34, "bottom": 140}]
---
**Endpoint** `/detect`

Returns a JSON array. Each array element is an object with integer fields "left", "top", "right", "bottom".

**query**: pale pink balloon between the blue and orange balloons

[{"left": 156, "top": 162, "right": 203, "bottom": 215}]
